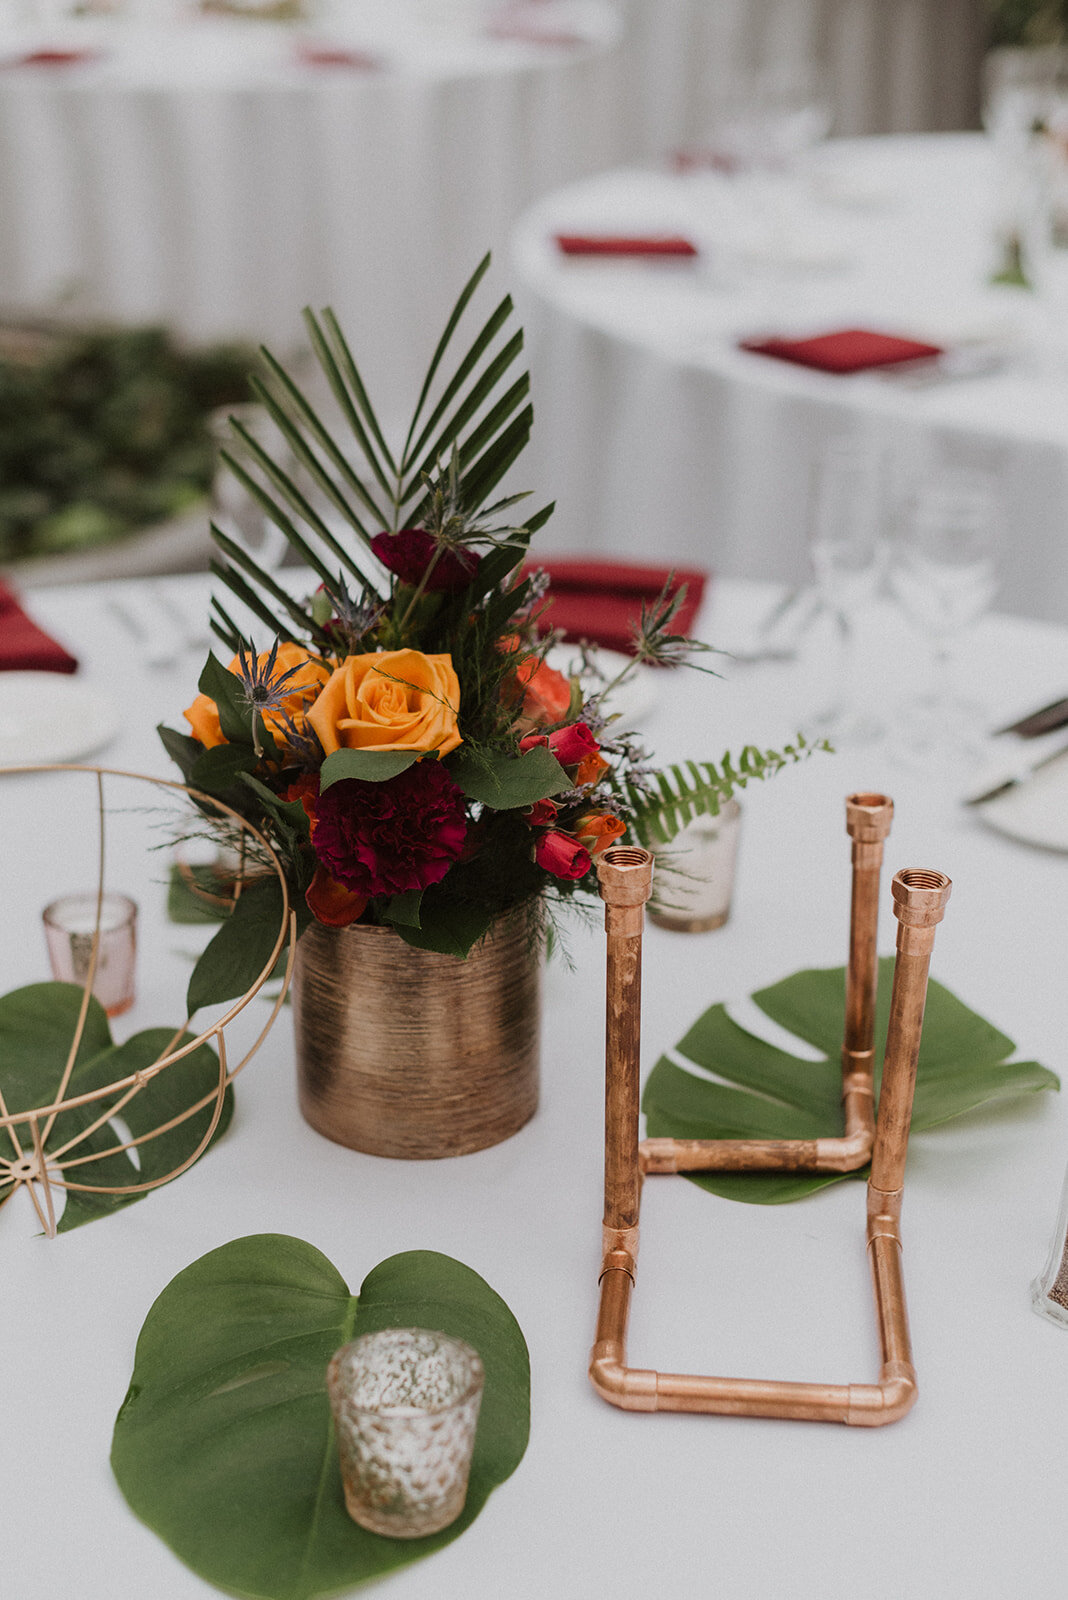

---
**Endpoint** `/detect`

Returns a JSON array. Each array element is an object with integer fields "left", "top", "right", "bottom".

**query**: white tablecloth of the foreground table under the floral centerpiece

[{"left": 0, "top": 578, "right": 1068, "bottom": 1600}]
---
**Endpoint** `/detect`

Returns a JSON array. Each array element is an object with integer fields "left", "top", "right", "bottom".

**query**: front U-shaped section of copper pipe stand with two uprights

[{"left": 590, "top": 851, "right": 950, "bottom": 1427}]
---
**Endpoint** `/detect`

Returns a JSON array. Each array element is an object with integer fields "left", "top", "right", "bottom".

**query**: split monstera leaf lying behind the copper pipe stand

[{"left": 643, "top": 958, "right": 1060, "bottom": 1205}]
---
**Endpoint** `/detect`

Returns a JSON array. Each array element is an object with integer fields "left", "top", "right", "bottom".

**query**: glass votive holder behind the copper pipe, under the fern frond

[{"left": 649, "top": 800, "right": 742, "bottom": 933}]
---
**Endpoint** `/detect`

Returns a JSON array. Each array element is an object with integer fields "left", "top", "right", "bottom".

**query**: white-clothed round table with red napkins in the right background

[{"left": 512, "top": 134, "right": 1068, "bottom": 621}]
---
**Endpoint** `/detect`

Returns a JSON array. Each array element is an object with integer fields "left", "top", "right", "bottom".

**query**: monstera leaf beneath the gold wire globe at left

[{"left": 0, "top": 984, "right": 233, "bottom": 1234}]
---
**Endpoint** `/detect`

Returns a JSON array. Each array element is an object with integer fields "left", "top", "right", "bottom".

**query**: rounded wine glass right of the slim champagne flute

[{"left": 891, "top": 470, "right": 998, "bottom": 762}]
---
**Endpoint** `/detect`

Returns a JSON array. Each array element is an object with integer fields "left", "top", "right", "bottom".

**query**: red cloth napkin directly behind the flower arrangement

[{"left": 524, "top": 557, "right": 708, "bottom": 654}]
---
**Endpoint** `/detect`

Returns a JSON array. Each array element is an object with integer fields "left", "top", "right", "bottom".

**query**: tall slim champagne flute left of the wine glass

[{"left": 809, "top": 438, "right": 886, "bottom": 744}]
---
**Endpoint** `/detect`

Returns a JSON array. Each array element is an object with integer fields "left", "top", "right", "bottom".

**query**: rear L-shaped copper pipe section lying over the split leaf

[{"left": 638, "top": 794, "right": 894, "bottom": 1173}]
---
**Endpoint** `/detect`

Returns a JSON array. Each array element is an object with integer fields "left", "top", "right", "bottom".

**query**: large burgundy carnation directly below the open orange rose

[{"left": 312, "top": 760, "right": 467, "bottom": 896}]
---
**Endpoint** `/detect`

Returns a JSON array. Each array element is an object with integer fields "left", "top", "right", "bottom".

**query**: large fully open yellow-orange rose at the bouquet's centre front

[{"left": 309, "top": 650, "right": 462, "bottom": 755}]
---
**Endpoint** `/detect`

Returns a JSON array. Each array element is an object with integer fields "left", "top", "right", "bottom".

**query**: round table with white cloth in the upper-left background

[{"left": 0, "top": 0, "right": 619, "bottom": 414}]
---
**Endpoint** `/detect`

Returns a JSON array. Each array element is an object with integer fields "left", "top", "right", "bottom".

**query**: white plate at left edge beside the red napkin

[{"left": 0, "top": 672, "right": 118, "bottom": 766}]
